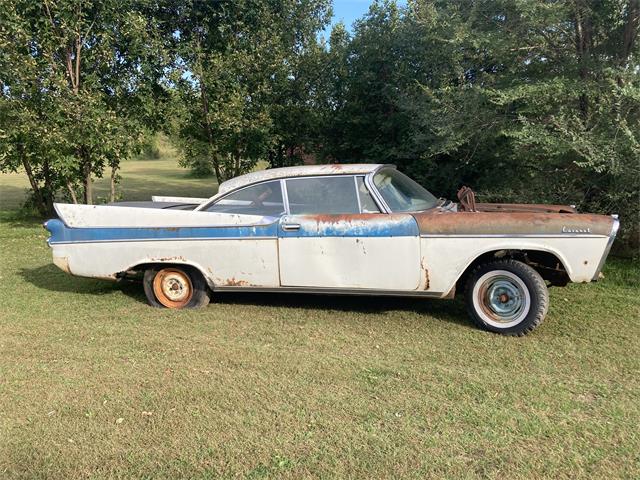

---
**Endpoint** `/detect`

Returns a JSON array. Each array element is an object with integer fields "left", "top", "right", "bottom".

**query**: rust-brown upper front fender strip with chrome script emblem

[{"left": 413, "top": 210, "right": 614, "bottom": 236}]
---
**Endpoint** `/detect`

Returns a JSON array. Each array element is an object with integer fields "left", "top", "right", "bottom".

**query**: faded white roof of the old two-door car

[{"left": 216, "top": 163, "right": 383, "bottom": 196}]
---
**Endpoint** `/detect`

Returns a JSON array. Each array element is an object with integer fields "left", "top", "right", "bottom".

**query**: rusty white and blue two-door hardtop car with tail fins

[{"left": 45, "top": 164, "right": 618, "bottom": 335}]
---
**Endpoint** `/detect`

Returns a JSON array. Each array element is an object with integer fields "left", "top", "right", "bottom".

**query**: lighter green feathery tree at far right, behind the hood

[{"left": 412, "top": 0, "right": 640, "bottom": 246}]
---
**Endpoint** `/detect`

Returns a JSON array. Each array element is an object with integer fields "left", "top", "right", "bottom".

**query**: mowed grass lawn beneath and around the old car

[{"left": 0, "top": 159, "right": 640, "bottom": 479}]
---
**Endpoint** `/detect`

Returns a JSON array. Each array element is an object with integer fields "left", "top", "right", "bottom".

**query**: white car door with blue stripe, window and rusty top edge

[{"left": 278, "top": 175, "right": 421, "bottom": 290}]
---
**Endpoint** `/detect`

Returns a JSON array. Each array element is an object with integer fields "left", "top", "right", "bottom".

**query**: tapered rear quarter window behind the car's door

[{"left": 206, "top": 180, "right": 284, "bottom": 217}]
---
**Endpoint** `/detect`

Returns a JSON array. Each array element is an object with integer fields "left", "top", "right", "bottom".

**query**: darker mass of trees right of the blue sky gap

[{"left": 322, "top": 0, "right": 640, "bottom": 251}]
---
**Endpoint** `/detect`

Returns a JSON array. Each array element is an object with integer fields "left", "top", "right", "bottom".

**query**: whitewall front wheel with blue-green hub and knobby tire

[{"left": 466, "top": 260, "right": 549, "bottom": 336}]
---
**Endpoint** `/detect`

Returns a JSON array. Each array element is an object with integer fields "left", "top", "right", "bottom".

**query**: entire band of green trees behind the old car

[{"left": 0, "top": 0, "right": 640, "bottom": 245}]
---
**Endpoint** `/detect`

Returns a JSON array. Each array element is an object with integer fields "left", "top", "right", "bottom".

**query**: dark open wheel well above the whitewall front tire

[{"left": 456, "top": 250, "right": 569, "bottom": 292}]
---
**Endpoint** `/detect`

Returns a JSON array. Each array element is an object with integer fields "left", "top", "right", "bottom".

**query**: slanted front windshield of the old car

[{"left": 373, "top": 168, "right": 438, "bottom": 212}]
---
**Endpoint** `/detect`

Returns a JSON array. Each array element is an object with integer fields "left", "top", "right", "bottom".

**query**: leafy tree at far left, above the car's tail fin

[{"left": 0, "top": 0, "right": 161, "bottom": 215}]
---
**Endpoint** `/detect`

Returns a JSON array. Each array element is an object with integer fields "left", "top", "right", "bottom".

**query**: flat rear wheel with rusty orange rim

[{"left": 143, "top": 265, "right": 209, "bottom": 308}]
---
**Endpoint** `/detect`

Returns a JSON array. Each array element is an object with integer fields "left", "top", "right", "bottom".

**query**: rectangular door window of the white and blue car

[{"left": 287, "top": 176, "right": 360, "bottom": 215}]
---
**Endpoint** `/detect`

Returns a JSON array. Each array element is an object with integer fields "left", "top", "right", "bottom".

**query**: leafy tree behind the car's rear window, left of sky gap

[{"left": 174, "top": 0, "right": 328, "bottom": 182}]
